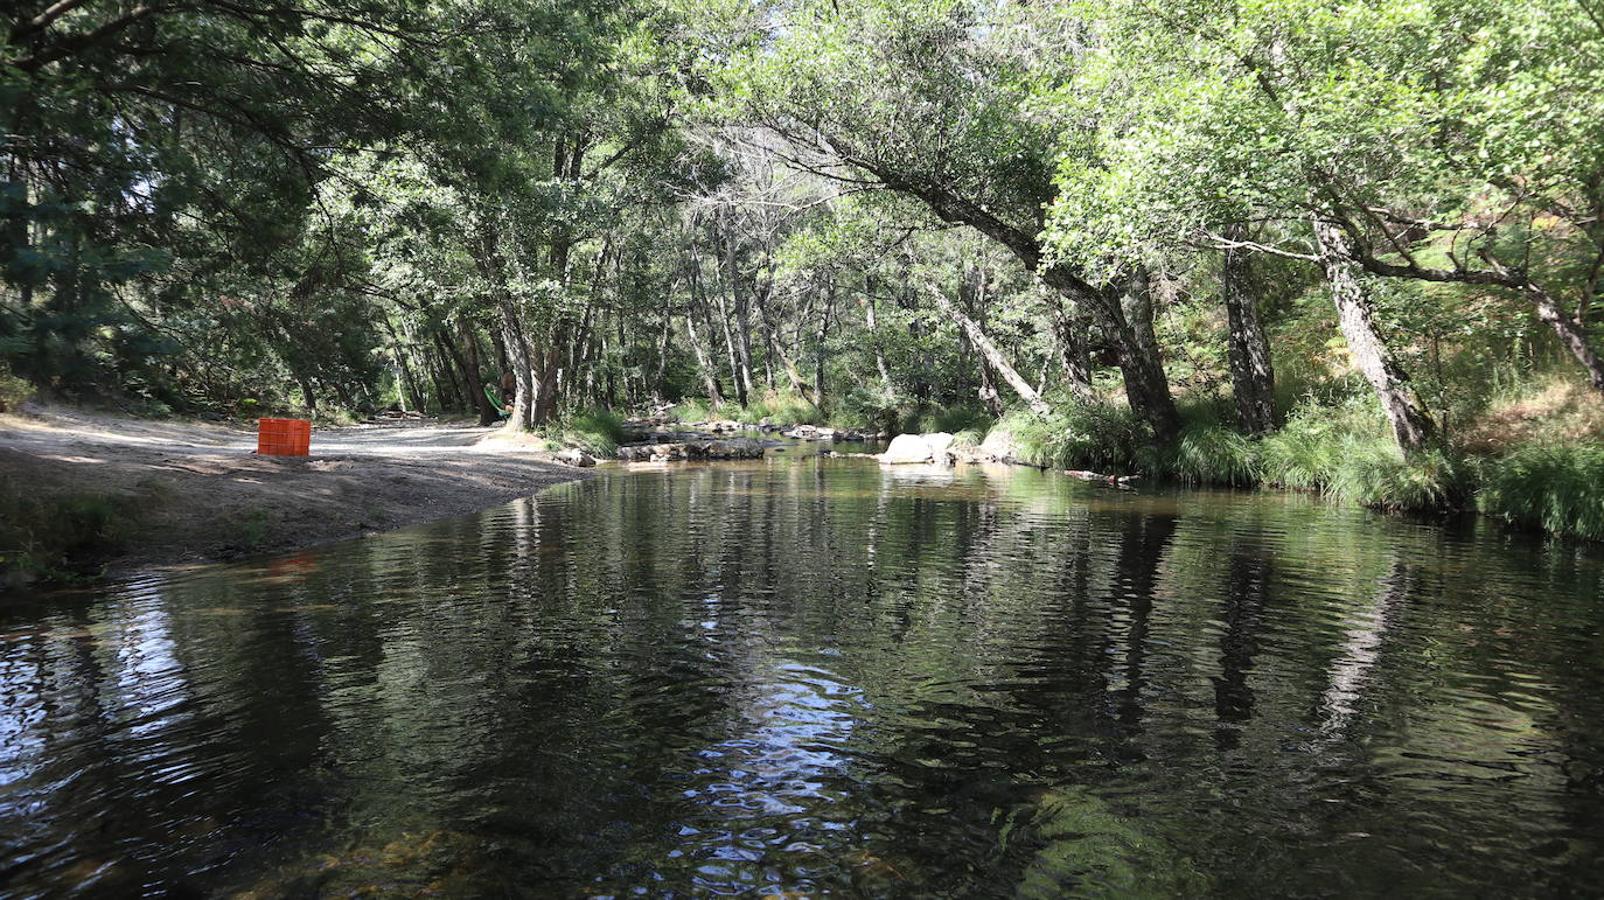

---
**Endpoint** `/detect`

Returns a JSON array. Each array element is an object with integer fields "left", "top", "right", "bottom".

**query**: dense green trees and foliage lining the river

[{"left": 0, "top": 0, "right": 1604, "bottom": 536}]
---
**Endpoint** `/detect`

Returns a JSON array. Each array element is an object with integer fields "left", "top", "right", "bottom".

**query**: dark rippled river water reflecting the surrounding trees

[{"left": 0, "top": 460, "right": 1604, "bottom": 895}]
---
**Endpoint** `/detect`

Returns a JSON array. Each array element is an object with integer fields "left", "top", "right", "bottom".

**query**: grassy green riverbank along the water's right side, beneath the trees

[{"left": 657, "top": 375, "right": 1604, "bottom": 541}]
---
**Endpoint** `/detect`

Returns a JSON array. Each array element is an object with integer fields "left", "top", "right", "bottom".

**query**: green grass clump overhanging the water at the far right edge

[{"left": 1476, "top": 443, "right": 1604, "bottom": 541}]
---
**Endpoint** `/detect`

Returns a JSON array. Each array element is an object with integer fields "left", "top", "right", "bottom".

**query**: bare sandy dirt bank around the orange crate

[{"left": 0, "top": 409, "right": 592, "bottom": 574}]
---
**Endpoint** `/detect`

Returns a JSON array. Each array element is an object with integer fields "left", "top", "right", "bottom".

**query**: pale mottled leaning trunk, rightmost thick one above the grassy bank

[{"left": 1314, "top": 218, "right": 1437, "bottom": 452}]
